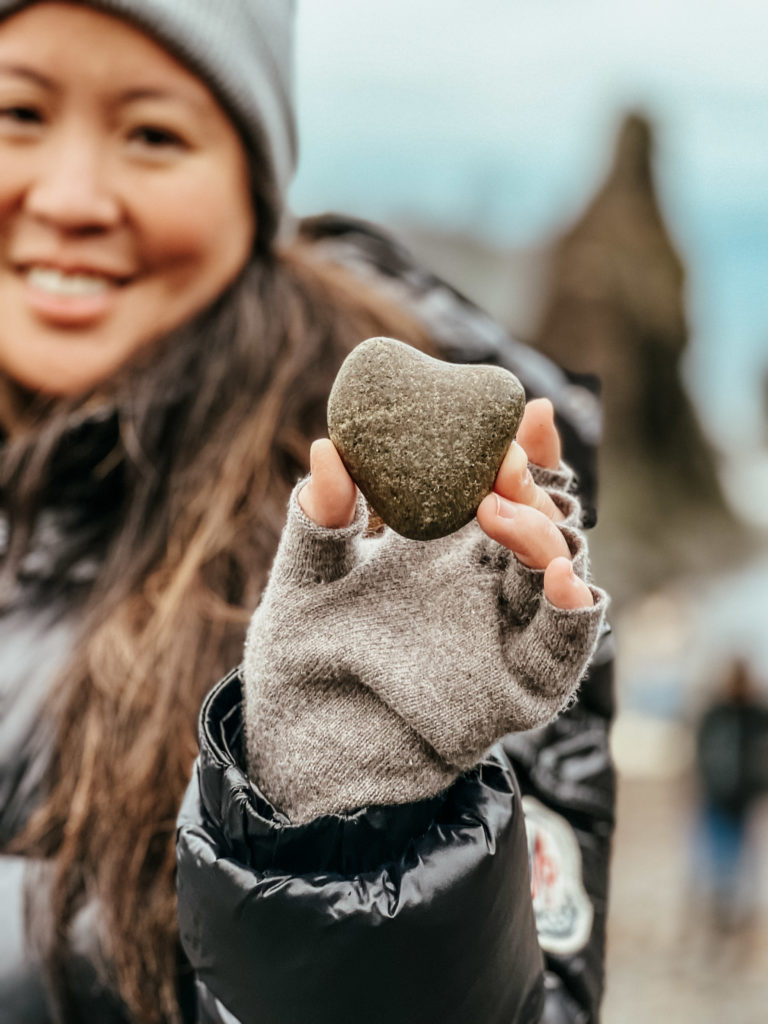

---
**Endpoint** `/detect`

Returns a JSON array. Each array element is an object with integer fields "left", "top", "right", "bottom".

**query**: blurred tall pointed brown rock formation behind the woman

[{"left": 532, "top": 114, "right": 739, "bottom": 602}]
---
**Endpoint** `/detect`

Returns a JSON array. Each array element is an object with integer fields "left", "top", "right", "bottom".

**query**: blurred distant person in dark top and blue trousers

[{"left": 695, "top": 657, "right": 768, "bottom": 953}]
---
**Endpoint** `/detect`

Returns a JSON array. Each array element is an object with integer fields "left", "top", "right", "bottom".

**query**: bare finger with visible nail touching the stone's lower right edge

[{"left": 477, "top": 494, "right": 570, "bottom": 569}]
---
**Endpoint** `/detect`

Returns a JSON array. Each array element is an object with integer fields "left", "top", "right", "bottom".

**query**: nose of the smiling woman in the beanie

[{"left": 26, "top": 131, "right": 120, "bottom": 233}]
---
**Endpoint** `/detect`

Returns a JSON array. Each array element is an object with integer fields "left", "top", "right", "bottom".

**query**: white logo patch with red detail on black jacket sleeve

[{"left": 522, "top": 797, "right": 594, "bottom": 956}]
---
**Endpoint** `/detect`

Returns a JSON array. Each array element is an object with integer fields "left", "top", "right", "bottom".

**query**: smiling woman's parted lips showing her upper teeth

[{"left": 22, "top": 266, "right": 125, "bottom": 327}]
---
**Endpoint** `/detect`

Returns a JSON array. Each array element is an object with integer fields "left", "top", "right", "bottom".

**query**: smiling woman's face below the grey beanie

[{"left": 0, "top": 3, "right": 255, "bottom": 395}]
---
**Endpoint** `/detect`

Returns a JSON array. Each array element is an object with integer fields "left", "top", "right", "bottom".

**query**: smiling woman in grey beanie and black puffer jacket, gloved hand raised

[{"left": 0, "top": 0, "right": 611, "bottom": 1024}]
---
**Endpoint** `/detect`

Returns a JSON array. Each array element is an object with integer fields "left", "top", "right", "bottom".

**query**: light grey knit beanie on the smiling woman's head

[{"left": 0, "top": 0, "right": 297, "bottom": 235}]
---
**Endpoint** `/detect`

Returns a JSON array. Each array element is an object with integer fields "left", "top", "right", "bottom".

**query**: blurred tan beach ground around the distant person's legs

[{"left": 602, "top": 772, "right": 768, "bottom": 1024}]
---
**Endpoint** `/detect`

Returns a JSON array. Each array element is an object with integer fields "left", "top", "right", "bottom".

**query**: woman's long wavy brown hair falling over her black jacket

[{"left": 0, "top": 234, "right": 426, "bottom": 1022}]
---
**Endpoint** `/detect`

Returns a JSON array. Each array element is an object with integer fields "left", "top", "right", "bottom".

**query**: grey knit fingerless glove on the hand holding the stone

[{"left": 243, "top": 467, "right": 607, "bottom": 823}]
